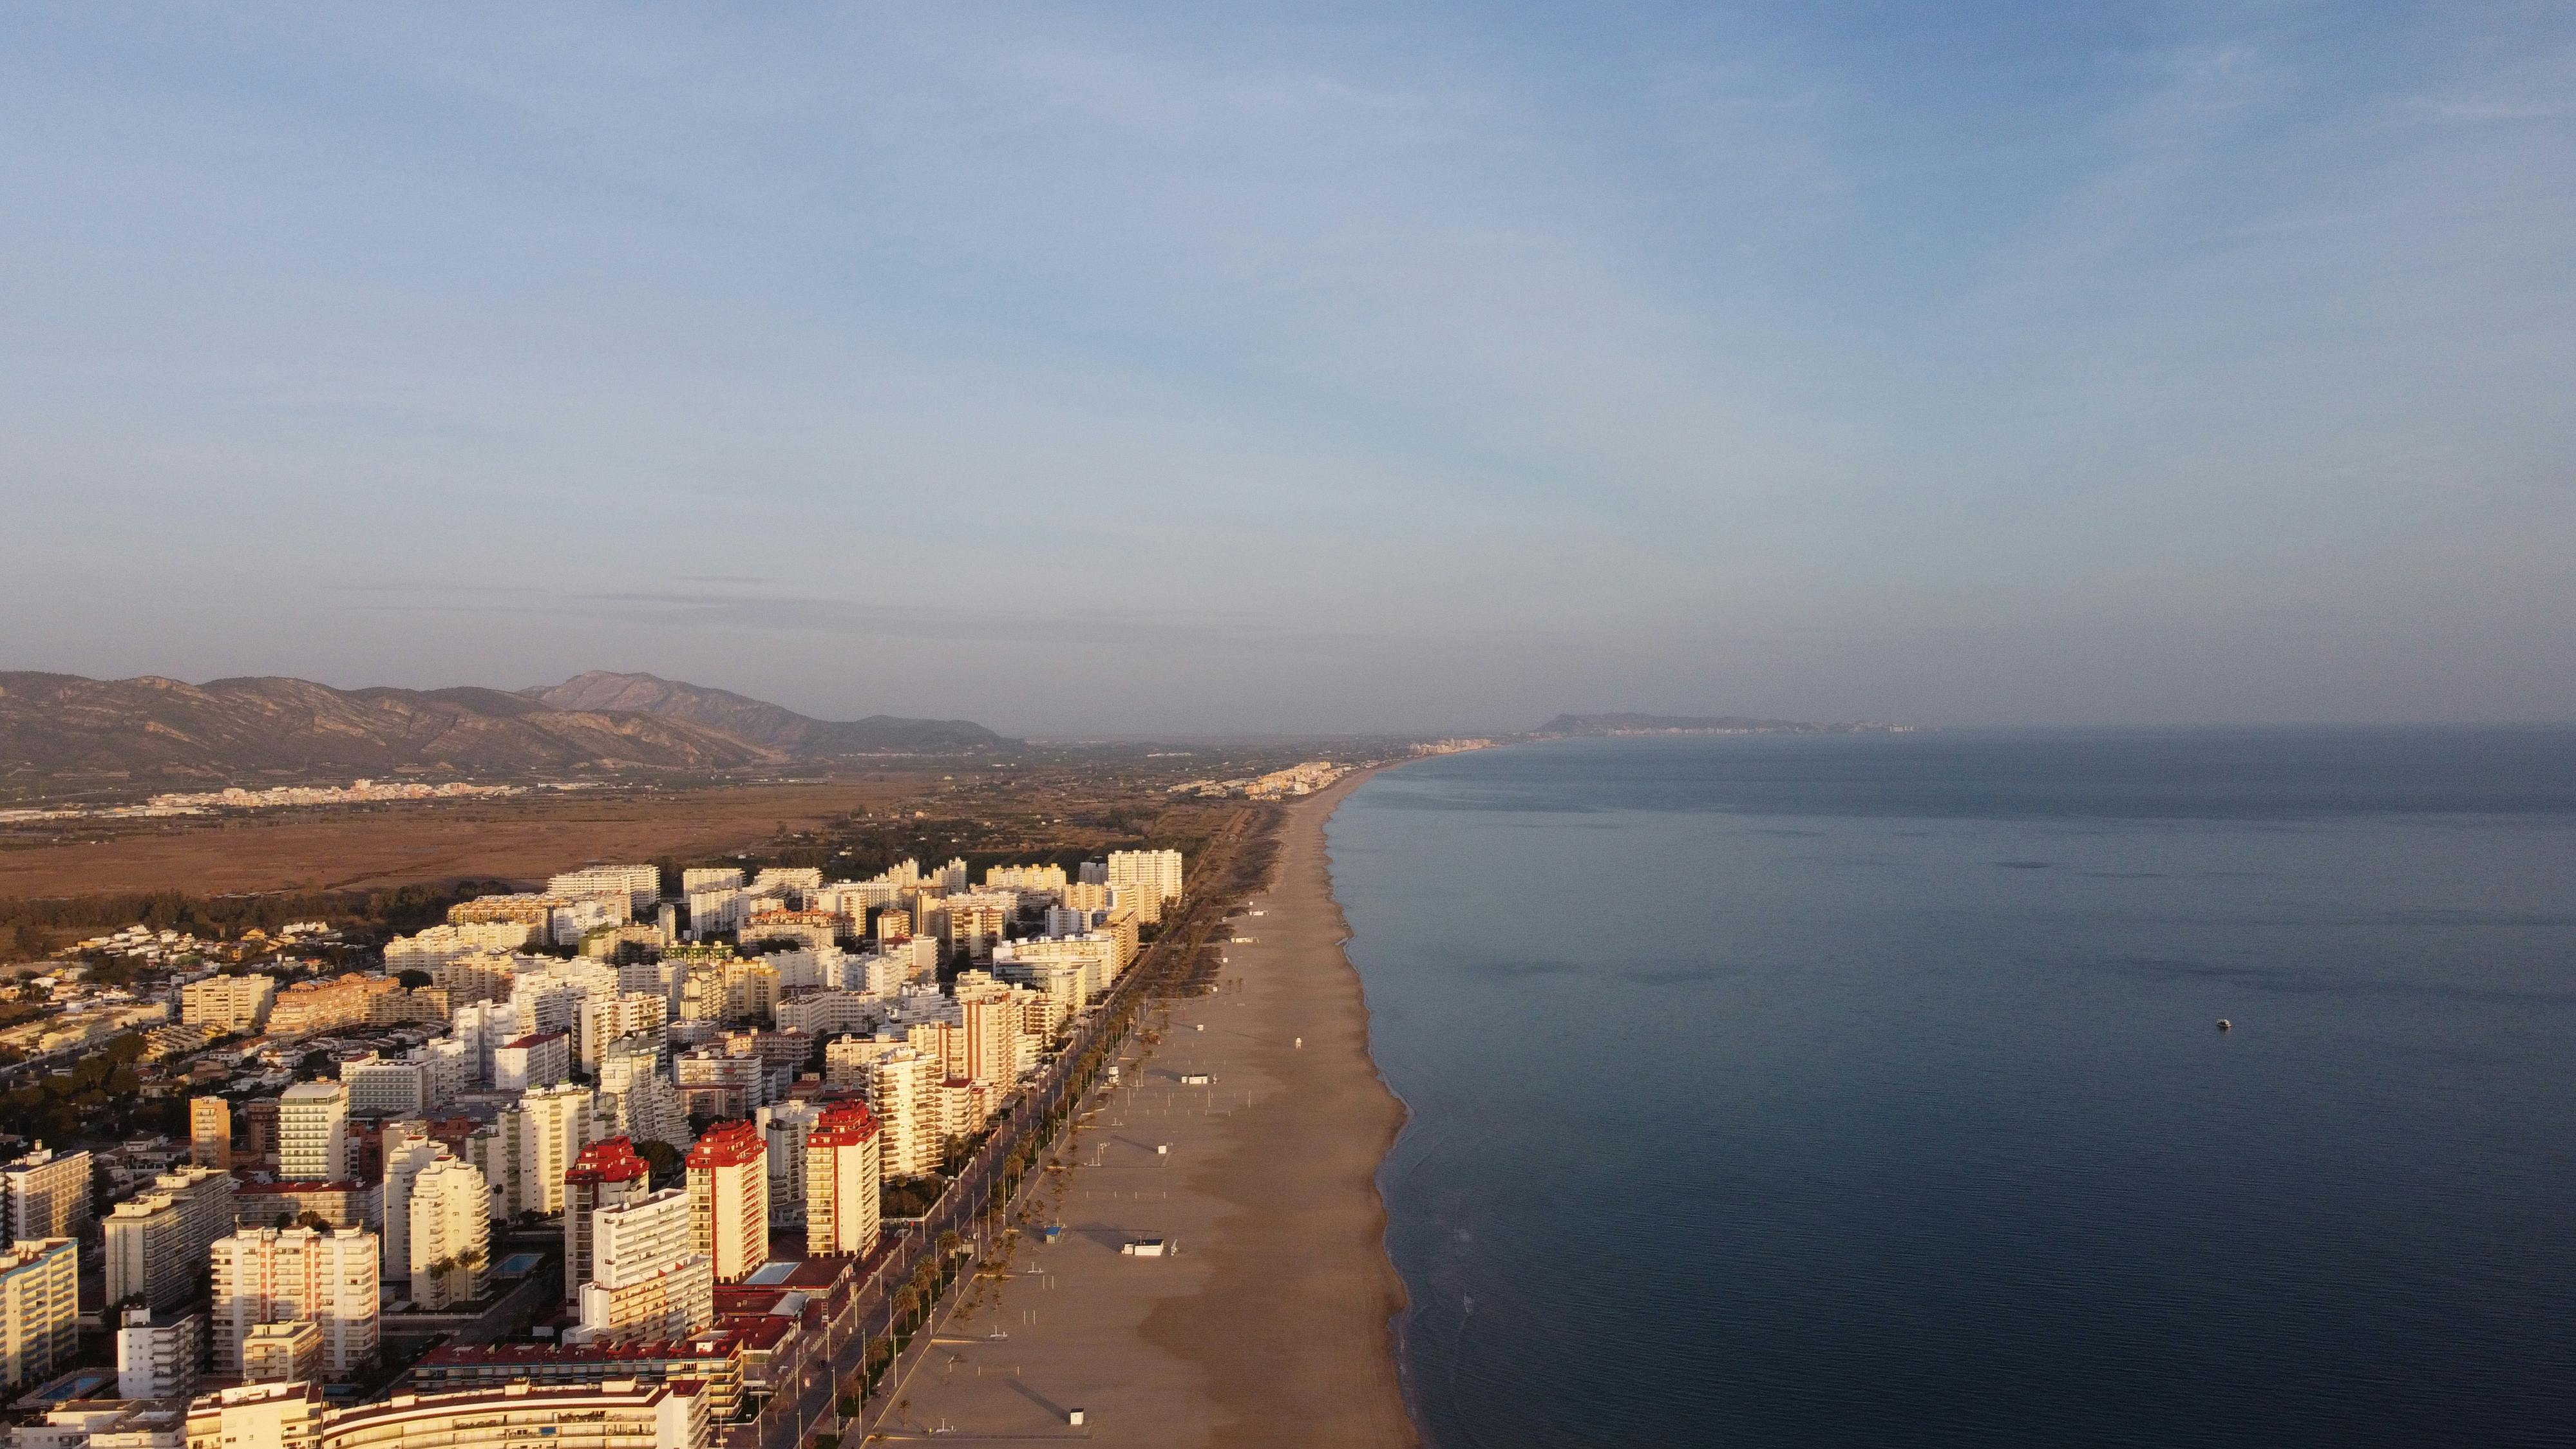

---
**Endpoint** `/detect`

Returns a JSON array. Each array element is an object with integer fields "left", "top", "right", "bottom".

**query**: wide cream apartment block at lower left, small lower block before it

[{"left": 209, "top": 1222, "right": 379, "bottom": 1377}]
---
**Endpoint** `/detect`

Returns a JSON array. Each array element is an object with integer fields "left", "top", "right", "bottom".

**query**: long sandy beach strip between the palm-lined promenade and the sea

[{"left": 881, "top": 779, "right": 1417, "bottom": 1446}]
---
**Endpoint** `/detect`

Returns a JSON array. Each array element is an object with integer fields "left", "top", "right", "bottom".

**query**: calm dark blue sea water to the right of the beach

[{"left": 1332, "top": 730, "right": 2576, "bottom": 1449}]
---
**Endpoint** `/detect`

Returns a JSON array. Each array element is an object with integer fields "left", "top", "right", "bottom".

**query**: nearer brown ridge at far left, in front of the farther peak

[{"left": 0, "top": 673, "right": 783, "bottom": 781}]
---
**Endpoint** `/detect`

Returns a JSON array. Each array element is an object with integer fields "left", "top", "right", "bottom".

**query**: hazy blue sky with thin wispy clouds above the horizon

[{"left": 0, "top": 0, "right": 2576, "bottom": 737}]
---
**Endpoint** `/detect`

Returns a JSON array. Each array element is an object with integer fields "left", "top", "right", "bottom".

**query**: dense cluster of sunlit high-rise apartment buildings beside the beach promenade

[{"left": 0, "top": 851, "right": 1182, "bottom": 1449}]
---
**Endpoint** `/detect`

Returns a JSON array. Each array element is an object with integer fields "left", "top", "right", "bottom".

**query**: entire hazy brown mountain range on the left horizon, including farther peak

[{"left": 0, "top": 673, "right": 1007, "bottom": 789}]
